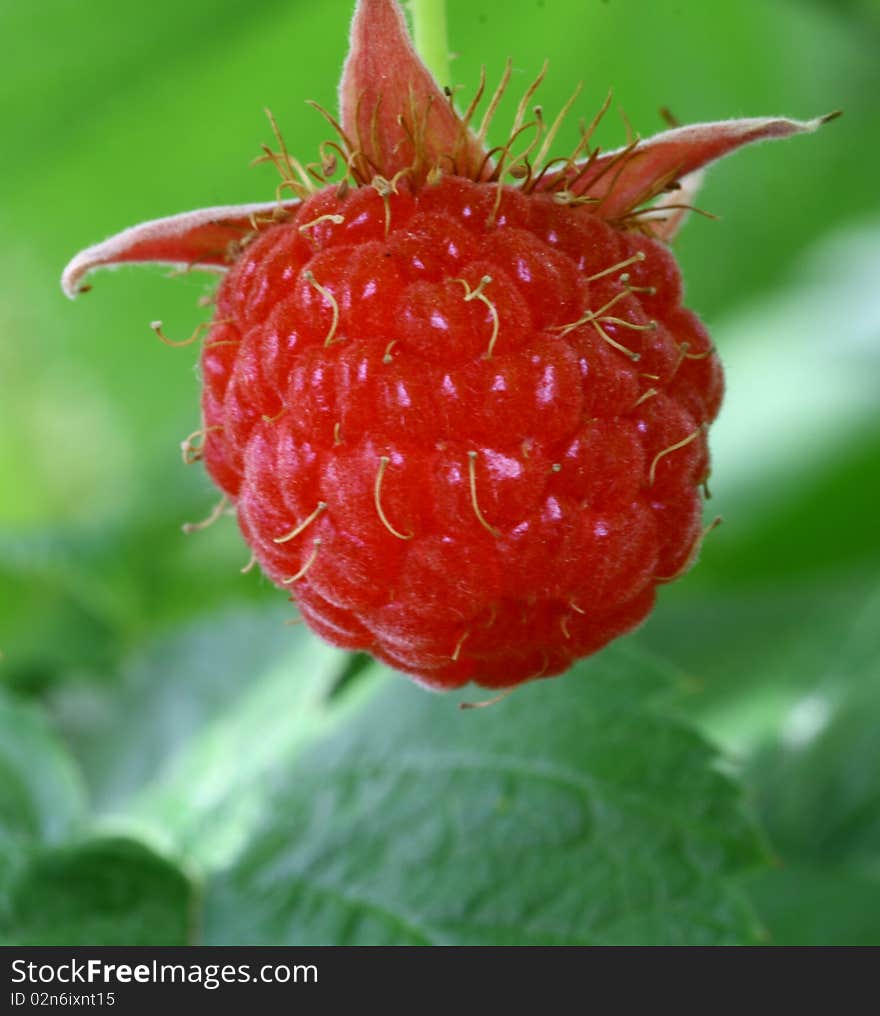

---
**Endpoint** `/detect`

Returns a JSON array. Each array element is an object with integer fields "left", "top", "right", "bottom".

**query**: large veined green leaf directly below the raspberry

[{"left": 204, "top": 647, "right": 760, "bottom": 945}]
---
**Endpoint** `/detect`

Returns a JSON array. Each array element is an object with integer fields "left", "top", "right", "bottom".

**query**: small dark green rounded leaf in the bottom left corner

[{"left": 0, "top": 838, "right": 196, "bottom": 946}]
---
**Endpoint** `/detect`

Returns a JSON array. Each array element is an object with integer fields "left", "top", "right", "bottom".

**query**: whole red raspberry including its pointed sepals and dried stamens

[{"left": 62, "top": 0, "right": 828, "bottom": 689}]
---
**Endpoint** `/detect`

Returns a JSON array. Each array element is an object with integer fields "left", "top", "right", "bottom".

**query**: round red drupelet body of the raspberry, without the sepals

[{"left": 202, "top": 177, "right": 721, "bottom": 688}]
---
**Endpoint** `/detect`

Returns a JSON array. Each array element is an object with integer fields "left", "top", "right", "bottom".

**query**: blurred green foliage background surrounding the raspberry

[{"left": 0, "top": 0, "right": 880, "bottom": 944}]
